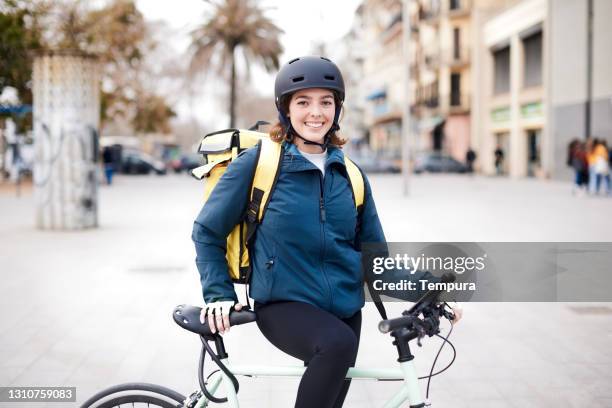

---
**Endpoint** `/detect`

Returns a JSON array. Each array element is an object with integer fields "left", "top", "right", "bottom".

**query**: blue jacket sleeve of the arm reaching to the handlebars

[{"left": 357, "top": 171, "right": 440, "bottom": 301}]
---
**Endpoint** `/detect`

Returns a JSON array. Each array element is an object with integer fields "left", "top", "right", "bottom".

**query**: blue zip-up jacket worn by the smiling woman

[{"left": 192, "top": 143, "right": 385, "bottom": 318}]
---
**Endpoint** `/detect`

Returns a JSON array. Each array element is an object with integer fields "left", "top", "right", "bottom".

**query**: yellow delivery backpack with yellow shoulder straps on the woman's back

[{"left": 191, "top": 129, "right": 365, "bottom": 283}]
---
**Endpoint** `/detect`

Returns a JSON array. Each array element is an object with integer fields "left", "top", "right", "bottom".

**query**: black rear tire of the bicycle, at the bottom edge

[{"left": 81, "top": 383, "right": 185, "bottom": 408}]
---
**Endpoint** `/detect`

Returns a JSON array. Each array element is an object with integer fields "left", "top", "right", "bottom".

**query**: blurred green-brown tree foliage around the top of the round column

[{"left": 0, "top": 0, "right": 174, "bottom": 132}]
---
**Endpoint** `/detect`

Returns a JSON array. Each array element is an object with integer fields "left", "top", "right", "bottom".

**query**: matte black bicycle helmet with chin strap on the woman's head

[{"left": 274, "top": 57, "right": 344, "bottom": 149}]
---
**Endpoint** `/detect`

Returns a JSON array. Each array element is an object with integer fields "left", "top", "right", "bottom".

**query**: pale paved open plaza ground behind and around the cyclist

[{"left": 0, "top": 175, "right": 612, "bottom": 408}]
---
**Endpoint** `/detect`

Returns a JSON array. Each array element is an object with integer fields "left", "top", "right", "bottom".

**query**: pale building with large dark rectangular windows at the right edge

[{"left": 471, "top": 0, "right": 612, "bottom": 178}]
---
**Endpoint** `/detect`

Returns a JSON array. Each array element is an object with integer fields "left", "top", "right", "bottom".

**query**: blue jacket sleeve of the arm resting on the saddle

[{"left": 191, "top": 148, "right": 257, "bottom": 303}]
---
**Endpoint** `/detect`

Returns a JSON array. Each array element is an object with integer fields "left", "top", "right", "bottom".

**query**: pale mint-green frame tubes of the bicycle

[{"left": 196, "top": 359, "right": 424, "bottom": 408}]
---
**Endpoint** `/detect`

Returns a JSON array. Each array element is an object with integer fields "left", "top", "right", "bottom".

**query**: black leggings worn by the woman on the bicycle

[{"left": 255, "top": 302, "right": 361, "bottom": 408}]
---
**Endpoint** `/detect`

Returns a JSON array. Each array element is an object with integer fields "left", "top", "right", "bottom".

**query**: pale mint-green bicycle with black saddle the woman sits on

[{"left": 81, "top": 275, "right": 456, "bottom": 408}]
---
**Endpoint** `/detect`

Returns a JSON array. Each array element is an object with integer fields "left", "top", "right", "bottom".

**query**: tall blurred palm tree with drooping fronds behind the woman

[{"left": 189, "top": 0, "right": 283, "bottom": 127}]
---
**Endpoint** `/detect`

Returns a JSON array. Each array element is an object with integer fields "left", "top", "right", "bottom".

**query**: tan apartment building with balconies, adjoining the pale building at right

[{"left": 410, "top": 0, "right": 516, "bottom": 161}]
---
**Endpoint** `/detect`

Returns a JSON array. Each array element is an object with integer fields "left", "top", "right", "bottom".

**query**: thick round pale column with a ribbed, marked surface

[{"left": 33, "top": 53, "right": 100, "bottom": 230}]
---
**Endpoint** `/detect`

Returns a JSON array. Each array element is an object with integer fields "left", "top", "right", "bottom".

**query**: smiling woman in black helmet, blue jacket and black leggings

[{"left": 193, "top": 57, "right": 460, "bottom": 408}]
